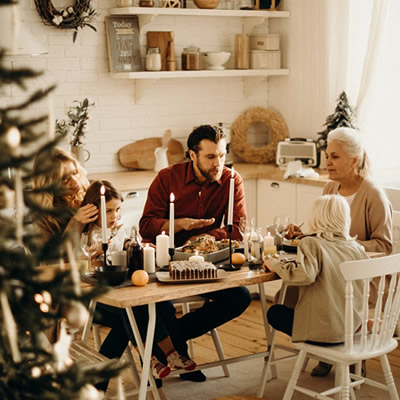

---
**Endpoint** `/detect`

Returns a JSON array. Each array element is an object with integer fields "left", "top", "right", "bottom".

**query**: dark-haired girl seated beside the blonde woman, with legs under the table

[{"left": 82, "top": 181, "right": 196, "bottom": 389}]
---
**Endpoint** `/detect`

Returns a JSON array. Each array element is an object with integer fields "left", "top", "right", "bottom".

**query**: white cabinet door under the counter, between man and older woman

[{"left": 256, "top": 179, "right": 297, "bottom": 232}]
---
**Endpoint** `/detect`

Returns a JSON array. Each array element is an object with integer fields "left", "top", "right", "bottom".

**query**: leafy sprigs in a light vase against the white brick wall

[{"left": 56, "top": 98, "right": 94, "bottom": 166}]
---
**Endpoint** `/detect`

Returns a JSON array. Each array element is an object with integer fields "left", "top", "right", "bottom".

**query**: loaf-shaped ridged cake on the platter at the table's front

[{"left": 169, "top": 260, "right": 217, "bottom": 281}]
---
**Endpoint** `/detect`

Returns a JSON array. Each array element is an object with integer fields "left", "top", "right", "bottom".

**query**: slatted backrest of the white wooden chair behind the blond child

[{"left": 339, "top": 254, "right": 400, "bottom": 353}]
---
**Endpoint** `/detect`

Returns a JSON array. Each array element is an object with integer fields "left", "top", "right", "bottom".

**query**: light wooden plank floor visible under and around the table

[{"left": 89, "top": 299, "right": 400, "bottom": 392}]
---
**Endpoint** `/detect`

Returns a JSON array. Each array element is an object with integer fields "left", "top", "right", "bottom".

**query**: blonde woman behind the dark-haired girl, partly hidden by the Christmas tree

[{"left": 33, "top": 147, "right": 98, "bottom": 239}]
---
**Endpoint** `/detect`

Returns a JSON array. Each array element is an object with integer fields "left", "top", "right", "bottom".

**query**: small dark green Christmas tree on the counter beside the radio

[{"left": 317, "top": 91, "right": 356, "bottom": 150}]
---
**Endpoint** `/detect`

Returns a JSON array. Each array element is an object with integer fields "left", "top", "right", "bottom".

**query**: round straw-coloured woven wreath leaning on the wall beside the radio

[{"left": 231, "top": 107, "right": 289, "bottom": 164}]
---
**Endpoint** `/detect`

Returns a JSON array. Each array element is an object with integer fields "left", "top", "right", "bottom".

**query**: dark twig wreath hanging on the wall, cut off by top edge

[{"left": 35, "top": 0, "right": 98, "bottom": 42}]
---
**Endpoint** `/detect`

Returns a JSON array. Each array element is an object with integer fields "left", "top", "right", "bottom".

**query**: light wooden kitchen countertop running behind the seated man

[{"left": 89, "top": 163, "right": 328, "bottom": 191}]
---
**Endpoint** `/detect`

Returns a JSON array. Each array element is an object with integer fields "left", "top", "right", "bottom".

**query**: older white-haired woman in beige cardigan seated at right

[{"left": 285, "top": 128, "right": 392, "bottom": 377}]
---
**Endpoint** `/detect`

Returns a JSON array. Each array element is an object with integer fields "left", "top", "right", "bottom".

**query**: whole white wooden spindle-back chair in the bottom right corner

[{"left": 283, "top": 254, "right": 400, "bottom": 400}]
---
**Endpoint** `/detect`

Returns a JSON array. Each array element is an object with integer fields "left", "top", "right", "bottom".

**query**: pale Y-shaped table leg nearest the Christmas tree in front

[{"left": 125, "top": 303, "right": 156, "bottom": 400}]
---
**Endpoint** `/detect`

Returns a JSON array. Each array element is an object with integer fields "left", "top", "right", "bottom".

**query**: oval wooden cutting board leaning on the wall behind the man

[{"left": 118, "top": 138, "right": 185, "bottom": 170}]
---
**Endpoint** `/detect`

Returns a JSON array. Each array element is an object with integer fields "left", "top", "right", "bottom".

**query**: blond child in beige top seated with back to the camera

[{"left": 266, "top": 195, "right": 368, "bottom": 344}]
